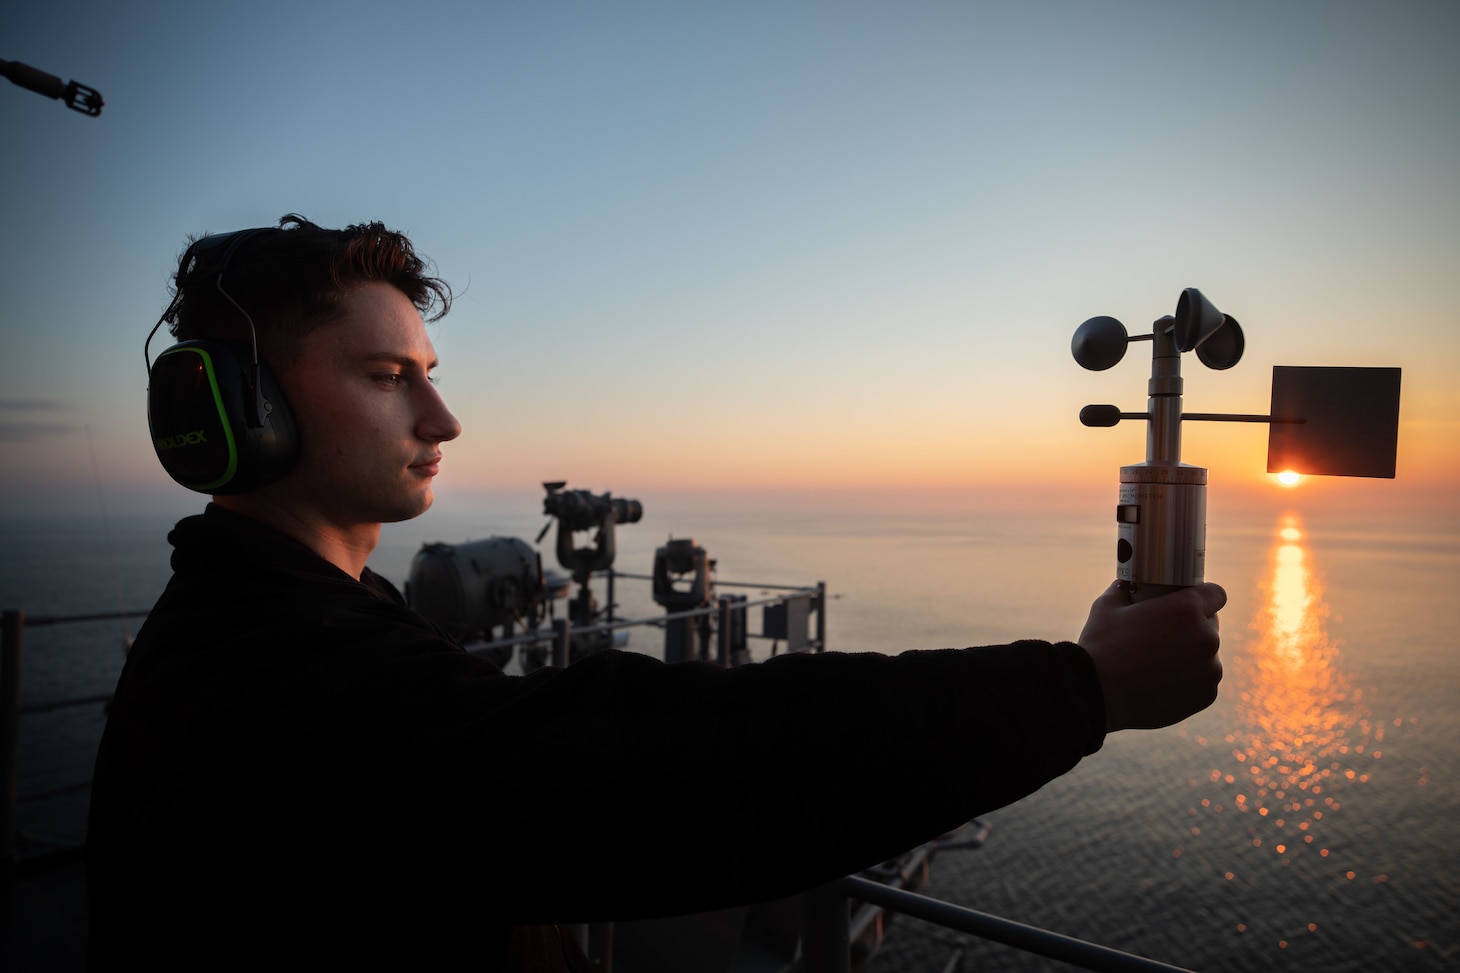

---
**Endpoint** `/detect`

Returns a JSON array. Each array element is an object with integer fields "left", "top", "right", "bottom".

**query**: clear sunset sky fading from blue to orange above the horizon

[{"left": 0, "top": 0, "right": 1460, "bottom": 513}]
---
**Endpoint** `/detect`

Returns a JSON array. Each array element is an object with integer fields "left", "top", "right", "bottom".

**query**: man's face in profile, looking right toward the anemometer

[{"left": 276, "top": 283, "right": 461, "bottom": 529}]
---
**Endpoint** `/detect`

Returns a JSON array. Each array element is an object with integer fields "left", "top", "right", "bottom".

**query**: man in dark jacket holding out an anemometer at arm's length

[{"left": 89, "top": 216, "right": 1225, "bottom": 970}]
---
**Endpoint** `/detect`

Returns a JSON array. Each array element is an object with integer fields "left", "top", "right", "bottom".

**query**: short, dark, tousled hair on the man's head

[{"left": 165, "top": 213, "right": 451, "bottom": 368}]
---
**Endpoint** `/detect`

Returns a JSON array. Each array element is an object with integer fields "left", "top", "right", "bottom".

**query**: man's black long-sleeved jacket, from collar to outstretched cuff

[{"left": 89, "top": 507, "right": 1105, "bottom": 969}]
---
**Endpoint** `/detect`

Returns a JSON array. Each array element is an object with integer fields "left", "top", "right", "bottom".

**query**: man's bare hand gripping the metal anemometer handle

[{"left": 1080, "top": 581, "right": 1226, "bottom": 730}]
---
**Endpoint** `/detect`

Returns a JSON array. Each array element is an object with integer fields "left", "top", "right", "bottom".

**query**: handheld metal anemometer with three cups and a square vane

[{"left": 1070, "top": 288, "right": 1400, "bottom": 599}]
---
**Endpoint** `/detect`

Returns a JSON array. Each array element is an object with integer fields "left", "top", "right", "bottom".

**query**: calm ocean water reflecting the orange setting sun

[{"left": 0, "top": 497, "right": 1460, "bottom": 973}]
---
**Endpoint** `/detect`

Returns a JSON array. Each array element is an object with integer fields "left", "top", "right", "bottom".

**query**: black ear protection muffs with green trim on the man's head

[{"left": 142, "top": 226, "right": 299, "bottom": 495}]
